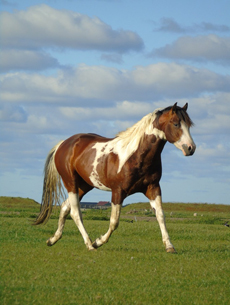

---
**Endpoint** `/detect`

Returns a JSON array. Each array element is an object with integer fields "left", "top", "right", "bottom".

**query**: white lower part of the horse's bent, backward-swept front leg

[{"left": 93, "top": 194, "right": 121, "bottom": 249}]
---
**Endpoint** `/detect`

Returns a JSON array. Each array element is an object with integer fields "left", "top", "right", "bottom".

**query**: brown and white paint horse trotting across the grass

[{"left": 34, "top": 104, "right": 196, "bottom": 253}]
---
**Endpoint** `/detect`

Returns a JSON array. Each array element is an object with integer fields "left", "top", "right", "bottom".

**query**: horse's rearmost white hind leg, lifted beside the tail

[{"left": 46, "top": 199, "right": 70, "bottom": 246}]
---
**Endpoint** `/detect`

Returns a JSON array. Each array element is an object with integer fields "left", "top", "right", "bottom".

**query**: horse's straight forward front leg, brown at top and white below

[{"left": 146, "top": 186, "right": 176, "bottom": 253}]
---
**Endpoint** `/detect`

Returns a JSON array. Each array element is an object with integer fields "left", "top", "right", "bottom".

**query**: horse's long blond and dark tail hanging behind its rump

[{"left": 34, "top": 141, "right": 63, "bottom": 225}]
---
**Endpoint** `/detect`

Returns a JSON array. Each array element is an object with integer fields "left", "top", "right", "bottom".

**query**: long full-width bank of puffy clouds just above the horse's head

[{"left": 0, "top": 63, "right": 230, "bottom": 107}]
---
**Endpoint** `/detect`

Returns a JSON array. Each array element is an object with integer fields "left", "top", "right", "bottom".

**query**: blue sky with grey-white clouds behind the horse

[{"left": 0, "top": 0, "right": 230, "bottom": 204}]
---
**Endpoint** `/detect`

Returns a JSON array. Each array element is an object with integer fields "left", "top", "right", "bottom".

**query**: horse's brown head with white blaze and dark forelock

[{"left": 158, "top": 103, "right": 196, "bottom": 156}]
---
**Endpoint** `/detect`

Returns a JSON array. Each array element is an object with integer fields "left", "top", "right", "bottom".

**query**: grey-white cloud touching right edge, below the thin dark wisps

[{"left": 152, "top": 34, "right": 230, "bottom": 65}]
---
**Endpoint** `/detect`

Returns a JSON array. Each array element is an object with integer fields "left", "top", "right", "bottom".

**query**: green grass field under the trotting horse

[{"left": 0, "top": 197, "right": 230, "bottom": 305}]
